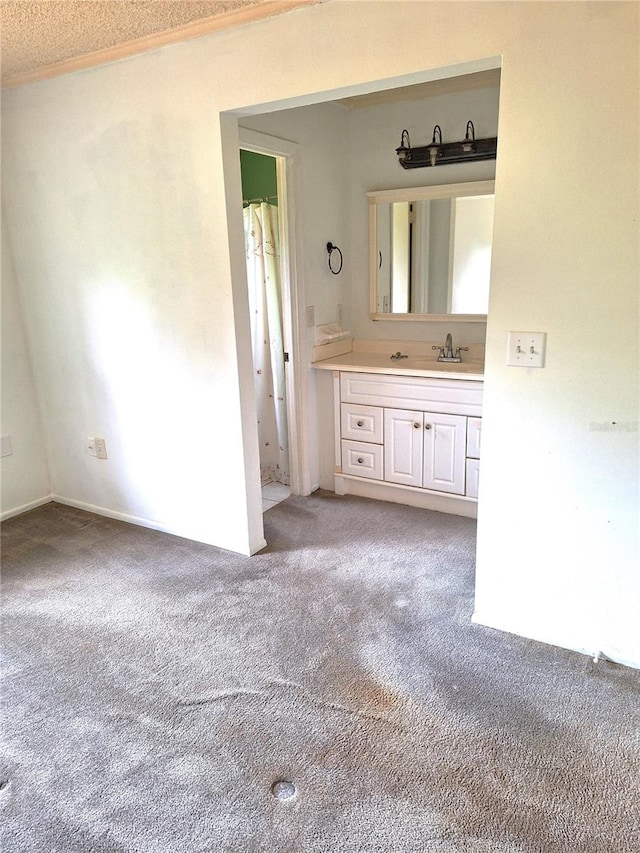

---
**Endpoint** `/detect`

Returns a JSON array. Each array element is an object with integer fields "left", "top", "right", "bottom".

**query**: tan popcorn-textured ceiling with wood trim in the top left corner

[{"left": 0, "top": 0, "right": 309, "bottom": 83}]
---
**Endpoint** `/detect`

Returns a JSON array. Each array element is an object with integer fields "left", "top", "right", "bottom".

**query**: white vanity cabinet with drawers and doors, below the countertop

[{"left": 334, "top": 371, "right": 482, "bottom": 516}]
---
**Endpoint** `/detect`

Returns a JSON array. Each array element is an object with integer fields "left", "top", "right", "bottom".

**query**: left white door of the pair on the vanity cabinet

[{"left": 384, "top": 409, "right": 424, "bottom": 487}]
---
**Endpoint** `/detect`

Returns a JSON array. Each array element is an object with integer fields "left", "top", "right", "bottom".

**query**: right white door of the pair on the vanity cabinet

[{"left": 422, "top": 412, "right": 467, "bottom": 495}]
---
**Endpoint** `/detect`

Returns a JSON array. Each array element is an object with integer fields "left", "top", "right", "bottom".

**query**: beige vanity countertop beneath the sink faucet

[{"left": 311, "top": 349, "right": 484, "bottom": 382}]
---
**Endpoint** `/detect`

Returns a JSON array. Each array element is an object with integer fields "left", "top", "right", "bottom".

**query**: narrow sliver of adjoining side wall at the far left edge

[{"left": 0, "top": 216, "right": 51, "bottom": 518}]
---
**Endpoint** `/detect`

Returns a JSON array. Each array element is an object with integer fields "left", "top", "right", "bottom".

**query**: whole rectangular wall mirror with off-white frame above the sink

[{"left": 367, "top": 181, "right": 494, "bottom": 323}]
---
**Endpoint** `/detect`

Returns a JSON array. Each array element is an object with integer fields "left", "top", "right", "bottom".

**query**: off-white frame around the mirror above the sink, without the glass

[{"left": 367, "top": 181, "right": 495, "bottom": 323}]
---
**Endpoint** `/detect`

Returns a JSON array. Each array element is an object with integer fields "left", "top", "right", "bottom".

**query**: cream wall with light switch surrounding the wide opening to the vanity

[{"left": 3, "top": 0, "right": 640, "bottom": 665}]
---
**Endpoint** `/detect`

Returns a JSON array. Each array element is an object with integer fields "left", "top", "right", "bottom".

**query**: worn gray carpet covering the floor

[{"left": 0, "top": 492, "right": 640, "bottom": 853}]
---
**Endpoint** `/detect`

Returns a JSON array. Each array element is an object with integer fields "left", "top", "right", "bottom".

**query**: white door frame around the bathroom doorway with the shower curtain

[{"left": 238, "top": 125, "right": 311, "bottom": 495}]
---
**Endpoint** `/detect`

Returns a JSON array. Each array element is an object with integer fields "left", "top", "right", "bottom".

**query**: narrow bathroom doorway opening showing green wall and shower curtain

[{"left": 240, "top": 148, "right": 292, "bottom": 512}]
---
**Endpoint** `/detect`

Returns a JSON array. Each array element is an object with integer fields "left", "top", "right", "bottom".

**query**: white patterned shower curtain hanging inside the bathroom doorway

[{"left": 244, "top": 203, "right": 290, "bottom": 485}]
